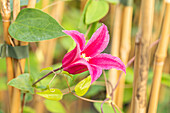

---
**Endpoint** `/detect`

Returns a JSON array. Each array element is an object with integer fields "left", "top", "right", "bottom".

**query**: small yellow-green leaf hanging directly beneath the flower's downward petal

[{"left": 75, "top": 76, "right": 91, "bottom": 96}]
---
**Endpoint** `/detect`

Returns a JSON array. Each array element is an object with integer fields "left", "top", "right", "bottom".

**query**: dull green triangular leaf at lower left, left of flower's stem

[{"left": 8, "top": 73, "right": 34, "bottom": 94}]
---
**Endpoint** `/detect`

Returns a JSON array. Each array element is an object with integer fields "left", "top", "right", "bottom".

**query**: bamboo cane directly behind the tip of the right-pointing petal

[{"left": 116, "top": 2, "right": 133, "bottom": 108}]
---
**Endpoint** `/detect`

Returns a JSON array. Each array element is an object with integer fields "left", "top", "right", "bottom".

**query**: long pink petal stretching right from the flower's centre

[{"left": 89, "top": 53, "right": 126, "bottom": 73}]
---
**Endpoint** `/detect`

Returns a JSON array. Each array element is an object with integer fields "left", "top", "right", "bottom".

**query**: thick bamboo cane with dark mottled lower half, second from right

[{"left": 132, "top": 0, "right": 154, "bottom": 113}]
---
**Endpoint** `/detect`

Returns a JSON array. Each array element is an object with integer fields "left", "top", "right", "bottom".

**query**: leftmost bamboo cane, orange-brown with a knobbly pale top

[{"left": 1, "top": 0, "right": 14, "bottom": 103}]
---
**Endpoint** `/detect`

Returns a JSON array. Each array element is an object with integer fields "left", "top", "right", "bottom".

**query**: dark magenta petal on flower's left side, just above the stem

[{"left": 62, "top": 45, "right": 80, "bottom": 68}]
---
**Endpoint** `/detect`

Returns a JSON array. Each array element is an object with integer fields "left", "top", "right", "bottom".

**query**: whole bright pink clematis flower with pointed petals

[{"left": 62, "top": 24, "right": 126, "bottom": 83}]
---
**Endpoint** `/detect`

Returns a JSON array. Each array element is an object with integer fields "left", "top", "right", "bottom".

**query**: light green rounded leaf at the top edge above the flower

[{"left": 85, "top": 0, "right": 109, "bottom": 24}]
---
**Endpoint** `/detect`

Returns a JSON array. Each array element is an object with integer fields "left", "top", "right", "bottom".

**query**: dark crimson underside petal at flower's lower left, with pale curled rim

[{"left": 63, "top": 58, "right": 90, "bottom": 74}]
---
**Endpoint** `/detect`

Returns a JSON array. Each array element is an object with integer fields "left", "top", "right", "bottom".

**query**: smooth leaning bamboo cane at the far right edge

[{"left": 148, "top": 2, "right": 170, "bottom": 113}]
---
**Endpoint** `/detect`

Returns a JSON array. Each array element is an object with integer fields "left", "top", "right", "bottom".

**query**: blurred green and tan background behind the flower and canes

[{"left": 0, "top": 0, "right": 170, "bottom": 113}]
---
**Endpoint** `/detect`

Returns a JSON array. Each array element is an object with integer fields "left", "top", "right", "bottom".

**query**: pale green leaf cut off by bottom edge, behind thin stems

[{"left": 93, "top": 102, "right": 123, "bottom": 113}]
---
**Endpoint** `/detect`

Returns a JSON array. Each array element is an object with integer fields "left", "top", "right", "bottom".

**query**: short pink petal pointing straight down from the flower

[{"left": 89, "top": 64, "right": 102, "bottom": 84}]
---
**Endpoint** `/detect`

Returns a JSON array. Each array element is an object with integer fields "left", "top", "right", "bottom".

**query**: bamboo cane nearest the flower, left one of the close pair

[{"left": 108, "top": 4, "right": 122, "bottom": 101}]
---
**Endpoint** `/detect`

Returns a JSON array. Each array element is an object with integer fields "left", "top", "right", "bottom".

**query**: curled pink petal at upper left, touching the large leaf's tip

[{"left": 63, "top": 30, "right": 86, "bottom": 50}]
